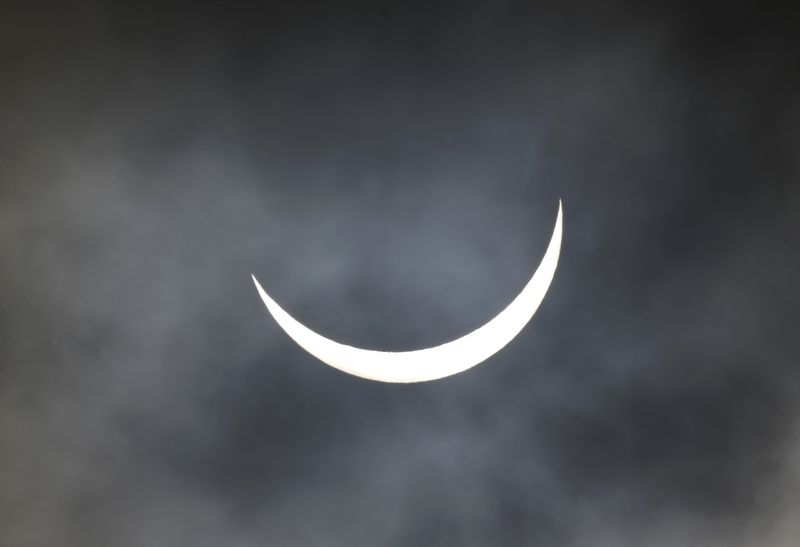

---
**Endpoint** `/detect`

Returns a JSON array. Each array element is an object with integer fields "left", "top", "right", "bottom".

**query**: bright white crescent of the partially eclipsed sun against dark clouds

[{"left": 253, "top": 201, "right": 562, "bottom": 383}]
